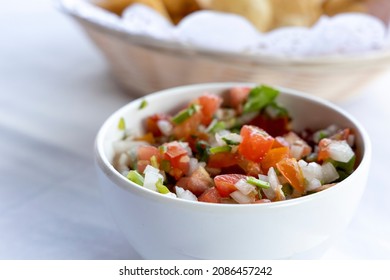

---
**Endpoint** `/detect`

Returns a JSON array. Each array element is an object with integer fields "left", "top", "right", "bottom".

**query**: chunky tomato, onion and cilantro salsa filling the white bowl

[{"left": 114, "top": 85, "right": 356, "bottom": 204}]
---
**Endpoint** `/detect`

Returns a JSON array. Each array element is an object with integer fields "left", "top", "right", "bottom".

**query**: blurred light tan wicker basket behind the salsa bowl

[{"left": 59, "top": 0, "right": 390, "bottom": 101}]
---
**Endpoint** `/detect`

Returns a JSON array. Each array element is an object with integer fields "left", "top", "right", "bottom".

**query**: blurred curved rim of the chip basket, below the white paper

[{"left": 57, "top": 0, "right": 390, "bottom": 69}]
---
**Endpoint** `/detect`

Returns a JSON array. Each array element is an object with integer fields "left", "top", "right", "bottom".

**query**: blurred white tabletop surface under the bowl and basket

[{"left": 0, "top": 0, "right": 390, "bottom": 259}]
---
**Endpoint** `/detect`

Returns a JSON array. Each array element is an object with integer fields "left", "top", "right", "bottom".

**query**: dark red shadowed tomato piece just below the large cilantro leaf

[{"left": 249, "top": 114, "right": 290, "bottom": 137}]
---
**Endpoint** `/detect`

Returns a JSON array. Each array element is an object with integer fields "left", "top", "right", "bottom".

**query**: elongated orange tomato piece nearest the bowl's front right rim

[{"left": 276, "top": 158, "right": 305, "bottom": 194}]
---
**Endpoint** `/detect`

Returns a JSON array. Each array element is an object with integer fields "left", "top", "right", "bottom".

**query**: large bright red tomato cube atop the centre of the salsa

[{"left": 238, "top": 125, "right": 274, "bottom": 162}]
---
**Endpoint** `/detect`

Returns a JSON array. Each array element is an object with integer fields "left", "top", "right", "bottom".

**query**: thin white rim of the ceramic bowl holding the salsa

[{"left": 94, "top": 82, "right": 372, "bottom": 209}]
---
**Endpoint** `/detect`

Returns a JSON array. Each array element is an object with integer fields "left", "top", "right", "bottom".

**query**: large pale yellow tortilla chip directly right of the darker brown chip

[{"left": 198, "top": 0, "right": 273, "bottom": 32}]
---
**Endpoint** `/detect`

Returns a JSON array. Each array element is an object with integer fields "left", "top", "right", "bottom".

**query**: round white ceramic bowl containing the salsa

[{"left": 95, "top": 83, "right": 371, "bottom": 259}]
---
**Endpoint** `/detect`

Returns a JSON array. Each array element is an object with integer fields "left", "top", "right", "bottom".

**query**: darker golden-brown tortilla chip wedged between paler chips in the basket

[{"left": 162, "top": 0, "right": 200, "bottom": 24}]
